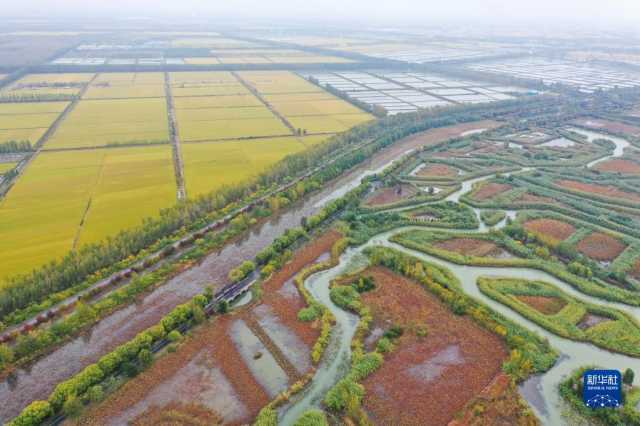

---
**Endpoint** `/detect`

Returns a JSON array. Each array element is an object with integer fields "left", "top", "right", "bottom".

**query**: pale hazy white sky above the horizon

[{"left": 0, "top": 0, "right": 640, "bottom": 25}]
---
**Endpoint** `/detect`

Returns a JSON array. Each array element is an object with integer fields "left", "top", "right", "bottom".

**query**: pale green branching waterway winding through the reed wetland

[{"left": 281, "top": 220, "right": 640, "bottom": 426}]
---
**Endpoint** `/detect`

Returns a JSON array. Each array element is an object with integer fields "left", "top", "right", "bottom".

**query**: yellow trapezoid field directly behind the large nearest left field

[{"left": 45, "top": 98, "right": 169, "bottom": 149}]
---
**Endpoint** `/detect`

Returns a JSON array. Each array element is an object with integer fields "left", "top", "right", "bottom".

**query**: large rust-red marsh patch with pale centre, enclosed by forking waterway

[{"left": 363, "top": 267, "right": 507, "bottom": 425}]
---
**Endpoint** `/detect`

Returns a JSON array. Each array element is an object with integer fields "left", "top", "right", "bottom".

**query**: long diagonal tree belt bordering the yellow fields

[{"left": 0, "top": 92, "right": 592, "bottom": 318}]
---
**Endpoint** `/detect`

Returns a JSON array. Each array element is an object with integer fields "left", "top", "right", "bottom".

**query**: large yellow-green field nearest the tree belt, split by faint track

[{"left": 0, "top": 146, "right": 176, "bottom": 279}]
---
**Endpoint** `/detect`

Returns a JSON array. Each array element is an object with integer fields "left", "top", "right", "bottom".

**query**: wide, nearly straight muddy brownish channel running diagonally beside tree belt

[{"left": 0, "top": 121, "right": 498, "bottom": 424}]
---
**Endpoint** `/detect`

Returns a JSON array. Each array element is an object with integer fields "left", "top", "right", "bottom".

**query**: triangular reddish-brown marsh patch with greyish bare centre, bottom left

[{"left": 78, "top": 315, "right": 270, "bottom": 425}]
